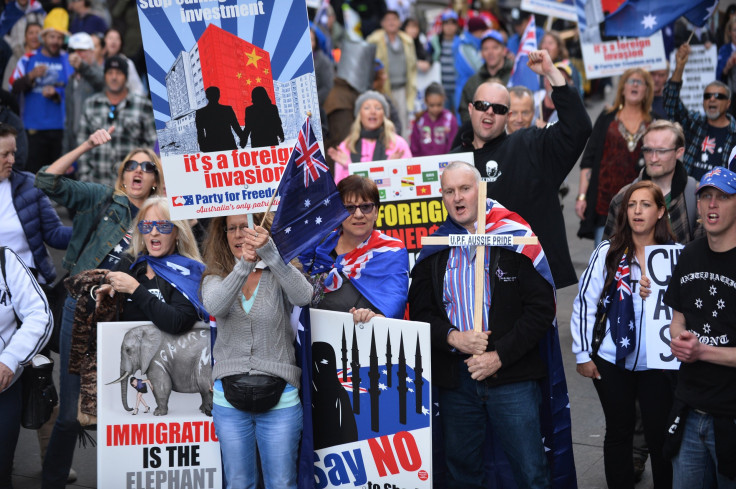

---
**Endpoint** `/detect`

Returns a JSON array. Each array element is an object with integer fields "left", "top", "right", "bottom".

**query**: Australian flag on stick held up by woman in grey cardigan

[{"left": 271, "top": 118, "right": 349, "bottom": 263}]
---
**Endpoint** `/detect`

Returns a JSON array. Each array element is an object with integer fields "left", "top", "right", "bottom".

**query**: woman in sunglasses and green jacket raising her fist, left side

[{"left": 36, "top": 128, "right": 161, "bottom": 489}]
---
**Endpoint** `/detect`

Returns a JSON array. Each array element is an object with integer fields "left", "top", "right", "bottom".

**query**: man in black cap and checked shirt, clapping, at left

[{"left": 77, "top": 56, "right": 156, "bottom": 187}]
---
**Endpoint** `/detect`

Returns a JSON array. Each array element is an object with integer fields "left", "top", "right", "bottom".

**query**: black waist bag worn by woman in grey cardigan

[{"left": 221, "top": 374, "right": 286, "bottom": 413}]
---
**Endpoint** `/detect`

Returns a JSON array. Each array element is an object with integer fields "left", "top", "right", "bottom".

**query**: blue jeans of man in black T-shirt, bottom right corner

[{"left": 672, "top": 410, "right": 736, "bottom": 489}]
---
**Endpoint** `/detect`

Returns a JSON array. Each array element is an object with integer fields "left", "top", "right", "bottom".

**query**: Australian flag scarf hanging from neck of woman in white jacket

[{"left": 606, "top": 252, "right": 636, "bottom": 368}]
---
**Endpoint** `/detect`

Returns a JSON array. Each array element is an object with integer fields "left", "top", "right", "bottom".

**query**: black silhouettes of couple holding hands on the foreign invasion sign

[{"left": 195, "top": 86, "right": 284, "bottom": 152}]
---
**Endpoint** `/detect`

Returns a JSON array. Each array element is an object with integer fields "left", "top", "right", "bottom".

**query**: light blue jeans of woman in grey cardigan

[{"left": 212, "top": 404, "right": 303, "bottom": 489}]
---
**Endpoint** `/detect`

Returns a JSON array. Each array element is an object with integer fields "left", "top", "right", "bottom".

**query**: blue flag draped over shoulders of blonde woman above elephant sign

[{"left": 130, "top": 253, "right": 210, "bottom": 321}]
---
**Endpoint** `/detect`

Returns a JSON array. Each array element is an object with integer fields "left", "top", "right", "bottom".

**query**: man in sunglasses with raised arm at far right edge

[{"left": 664, "top": 44, "right": 736, "bottom": 180}]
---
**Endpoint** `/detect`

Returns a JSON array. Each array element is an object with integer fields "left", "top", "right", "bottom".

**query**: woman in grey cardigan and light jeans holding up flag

[{"left": 202, "top": 214, "right": 312, "bottom": 489}]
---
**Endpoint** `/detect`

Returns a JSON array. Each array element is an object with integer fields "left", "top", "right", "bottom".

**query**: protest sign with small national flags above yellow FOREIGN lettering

[{"left": 350, "top": 153, "right": 473, "bottom": 267}]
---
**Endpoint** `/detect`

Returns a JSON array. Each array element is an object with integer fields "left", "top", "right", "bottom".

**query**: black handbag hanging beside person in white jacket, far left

[{"left": 20, "top": 355, "right": 59, "bottom": 430}]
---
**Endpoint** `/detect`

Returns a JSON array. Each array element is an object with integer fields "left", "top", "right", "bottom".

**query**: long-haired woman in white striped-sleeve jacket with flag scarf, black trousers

[{"left": 570, "top": 180, "right": 674, "bottom": 488}]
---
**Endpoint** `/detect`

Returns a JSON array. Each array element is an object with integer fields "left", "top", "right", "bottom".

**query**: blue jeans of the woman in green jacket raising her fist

[{"left": 42, "top": 297, "right": 82, "bottom": 489}]
